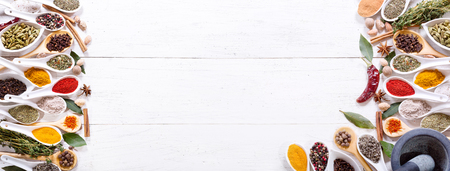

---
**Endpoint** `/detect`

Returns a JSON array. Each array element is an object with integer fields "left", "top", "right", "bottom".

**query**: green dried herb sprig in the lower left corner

[{"left": 0, "top": 121, "right": 61, "bottom": 157}]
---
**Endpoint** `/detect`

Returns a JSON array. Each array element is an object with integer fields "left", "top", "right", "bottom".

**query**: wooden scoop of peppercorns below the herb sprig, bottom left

[{"left": 0, "top": 150, "right": 78, "bottom": 171}]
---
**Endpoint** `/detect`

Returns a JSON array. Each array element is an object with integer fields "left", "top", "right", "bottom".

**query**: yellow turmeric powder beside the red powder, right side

[{"left": 414, "top": 69, "right": 445, "bottom": 89}]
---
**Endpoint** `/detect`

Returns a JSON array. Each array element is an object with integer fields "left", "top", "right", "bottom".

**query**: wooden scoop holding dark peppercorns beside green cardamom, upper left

[{"left": 0, "top": 30, "right": 74, "bottom": 70}]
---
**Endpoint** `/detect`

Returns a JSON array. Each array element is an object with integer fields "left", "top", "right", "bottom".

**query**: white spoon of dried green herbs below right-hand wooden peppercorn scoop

[{"left": 390, "top": 53, "right": 450, "bottom": 74}]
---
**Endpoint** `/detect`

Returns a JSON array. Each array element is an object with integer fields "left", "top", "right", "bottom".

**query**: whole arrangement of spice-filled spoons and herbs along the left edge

[{"left": 0, "top": 0, "right": 92, "bottom": 171}]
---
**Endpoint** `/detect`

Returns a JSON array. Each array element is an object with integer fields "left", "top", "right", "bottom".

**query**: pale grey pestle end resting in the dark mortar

[{"left": 395, "top": 154, "right": 434, "bottom": 171}]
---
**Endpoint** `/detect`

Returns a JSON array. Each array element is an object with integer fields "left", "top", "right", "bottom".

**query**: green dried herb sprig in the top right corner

[{"left": 392, "top": 0, "right": 450, "bottom": 33}]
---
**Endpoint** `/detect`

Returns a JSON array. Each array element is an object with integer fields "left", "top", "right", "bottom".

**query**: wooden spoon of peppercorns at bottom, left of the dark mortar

[{"left": 333, "top": 127, "right": 372, "bottom": 171}]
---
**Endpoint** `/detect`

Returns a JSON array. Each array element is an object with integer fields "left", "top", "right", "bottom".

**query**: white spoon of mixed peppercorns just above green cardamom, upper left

[{"left": 5, "top": 8, "right": 66, "bottom": 31}]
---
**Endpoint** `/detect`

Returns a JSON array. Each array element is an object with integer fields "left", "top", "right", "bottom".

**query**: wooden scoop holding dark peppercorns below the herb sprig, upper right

[{"left": 393, "top": 30, "right": 447, "bottom": 58}]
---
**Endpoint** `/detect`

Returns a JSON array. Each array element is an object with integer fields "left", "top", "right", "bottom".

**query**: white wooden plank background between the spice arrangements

[{"left": 0, "top": 0, "right": 447, "bottom": 171}]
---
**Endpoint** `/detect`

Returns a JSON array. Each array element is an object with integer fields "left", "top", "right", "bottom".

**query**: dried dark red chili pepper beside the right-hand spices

[{"left": 356, "top": 58, "right": 380, "bottom": 103}]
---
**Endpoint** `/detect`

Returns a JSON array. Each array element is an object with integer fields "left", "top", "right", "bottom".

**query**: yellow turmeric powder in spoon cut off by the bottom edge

[{"left": 288, "top": 144, "right": 308, "bottom": 171}]
